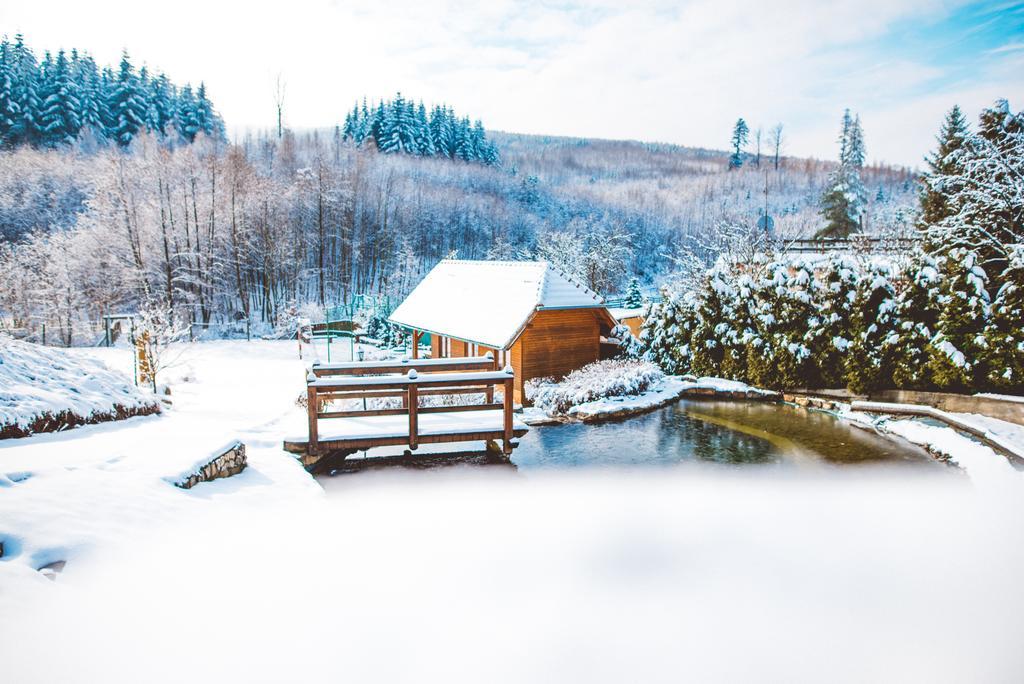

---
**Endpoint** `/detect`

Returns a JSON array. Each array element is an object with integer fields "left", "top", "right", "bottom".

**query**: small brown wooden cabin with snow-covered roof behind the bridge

[{"left": 389, "top": 259, "right": 616, "bottom": 403}]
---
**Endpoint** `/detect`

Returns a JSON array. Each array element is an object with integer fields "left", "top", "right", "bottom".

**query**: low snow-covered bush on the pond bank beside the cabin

[{"left": 526, "top": 359, "right": 665, "bottom": 416}]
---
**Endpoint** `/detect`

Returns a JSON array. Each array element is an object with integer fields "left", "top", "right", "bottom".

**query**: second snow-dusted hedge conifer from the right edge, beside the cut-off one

[{"left": 928, "top": 248, "right": 990, "bottom": 391}]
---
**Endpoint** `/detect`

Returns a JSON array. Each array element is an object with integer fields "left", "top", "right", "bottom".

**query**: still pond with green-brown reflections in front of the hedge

[{"left": 512, "top": 399, "right": 936, "bottom": 470}]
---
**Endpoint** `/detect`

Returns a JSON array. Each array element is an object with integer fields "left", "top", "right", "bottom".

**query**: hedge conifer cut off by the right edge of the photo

[{"left": 985, "top": 245, "right": 1024, "bottom": 394}]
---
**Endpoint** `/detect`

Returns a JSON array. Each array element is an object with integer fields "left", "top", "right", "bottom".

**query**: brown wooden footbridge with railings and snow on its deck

[{"left": 285, "top": 354, "right": 528, "bottom": 469}]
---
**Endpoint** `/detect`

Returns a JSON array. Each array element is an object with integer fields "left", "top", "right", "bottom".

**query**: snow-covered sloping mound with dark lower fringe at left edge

[{"left": 0, "top": 335, "right": 160, "bottom": 439}]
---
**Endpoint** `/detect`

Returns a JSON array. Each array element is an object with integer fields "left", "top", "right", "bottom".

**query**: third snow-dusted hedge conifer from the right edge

[{"left": 891, "top": 249, "right": 942, "bottom": 389}]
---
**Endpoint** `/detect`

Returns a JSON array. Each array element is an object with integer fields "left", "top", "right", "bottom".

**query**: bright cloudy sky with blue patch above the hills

[{"left": 0, "top": 0, "right": 1024, "bottom": 167}]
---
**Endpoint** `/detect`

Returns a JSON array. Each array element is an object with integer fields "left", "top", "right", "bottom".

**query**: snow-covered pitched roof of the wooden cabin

[{"left": 389, "top": 259, "right": 604, "bottom": 349}]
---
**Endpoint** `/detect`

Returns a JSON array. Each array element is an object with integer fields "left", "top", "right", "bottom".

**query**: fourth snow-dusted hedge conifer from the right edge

[{"left": 846, "top": 262, "right": 899, "bottom": 394}]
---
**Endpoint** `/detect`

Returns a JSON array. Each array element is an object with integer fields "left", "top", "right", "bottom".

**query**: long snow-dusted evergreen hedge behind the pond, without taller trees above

[{"left": 640, "top": 246, "right": 1024, "bottom": 393}]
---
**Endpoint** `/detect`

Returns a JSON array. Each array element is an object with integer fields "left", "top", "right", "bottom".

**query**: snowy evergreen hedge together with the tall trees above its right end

[{"left": 642, "top": 100, "right": 1024, "bottom": 392}]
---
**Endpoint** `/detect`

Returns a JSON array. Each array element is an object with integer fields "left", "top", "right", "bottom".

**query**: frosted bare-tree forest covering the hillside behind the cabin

[{"left": 0, "top": 92, "right": 914, "bottom": 343}]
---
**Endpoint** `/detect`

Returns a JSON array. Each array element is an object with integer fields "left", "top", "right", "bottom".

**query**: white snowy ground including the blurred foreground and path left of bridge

[{"left": 0, "top": 341, "right": 1024, "bottom": 683}]
